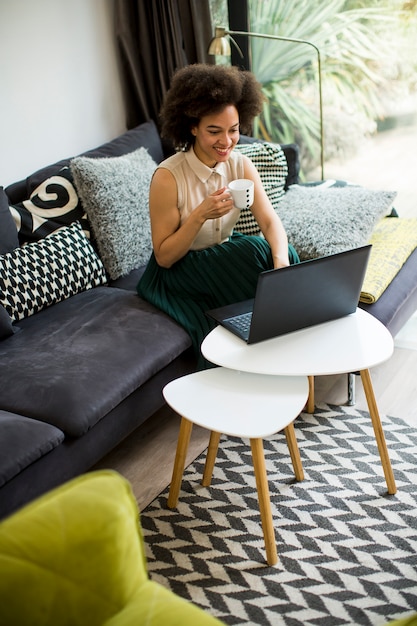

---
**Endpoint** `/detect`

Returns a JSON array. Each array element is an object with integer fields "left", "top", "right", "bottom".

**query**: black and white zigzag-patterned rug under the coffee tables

[{"left": 141, "top": 404, "right": 417, "bottom": 626}]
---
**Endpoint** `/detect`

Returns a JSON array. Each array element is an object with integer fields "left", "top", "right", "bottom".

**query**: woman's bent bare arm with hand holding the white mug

[{"left": 149, "top": 168, "right": 233, "bottom": 268}]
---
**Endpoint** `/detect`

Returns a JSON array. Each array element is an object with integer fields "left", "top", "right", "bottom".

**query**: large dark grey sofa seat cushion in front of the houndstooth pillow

[{"left": 0, "top": 286, "right": 191, "bottom": 437}]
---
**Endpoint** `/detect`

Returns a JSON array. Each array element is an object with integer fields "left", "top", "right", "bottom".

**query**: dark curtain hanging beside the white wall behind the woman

[{"left": 115, "top": 0, "right": 213, "bottom": 128}]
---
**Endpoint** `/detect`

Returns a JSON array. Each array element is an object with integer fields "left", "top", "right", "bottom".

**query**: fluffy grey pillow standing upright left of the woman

[{"left": 71, "top": 148, "right": 156, "bottom": 280}]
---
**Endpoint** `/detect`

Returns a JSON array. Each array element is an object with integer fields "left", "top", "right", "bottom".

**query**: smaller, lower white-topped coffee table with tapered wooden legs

[{"left": 163, "top": 367, "right": 308, "bottom": 565}]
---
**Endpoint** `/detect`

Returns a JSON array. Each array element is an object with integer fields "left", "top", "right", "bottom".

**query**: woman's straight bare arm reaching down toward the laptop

[{"left": 242, "top": 155, "right": 290, "bottom": 268}]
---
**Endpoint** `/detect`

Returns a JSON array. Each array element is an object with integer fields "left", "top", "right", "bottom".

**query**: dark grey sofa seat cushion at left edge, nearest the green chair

[{"left": 0, "top": 410, "right": 64, "bottom": 487}]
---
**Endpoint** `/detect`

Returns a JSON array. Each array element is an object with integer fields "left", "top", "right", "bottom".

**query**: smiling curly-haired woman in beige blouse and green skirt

[{"left": 137, "top": 64, "right": 298, "bottom": 368}]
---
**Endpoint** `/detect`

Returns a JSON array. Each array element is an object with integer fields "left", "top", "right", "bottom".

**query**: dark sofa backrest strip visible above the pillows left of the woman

[{"left": 5, "top": 121, "right": 164, "bottom": 204}]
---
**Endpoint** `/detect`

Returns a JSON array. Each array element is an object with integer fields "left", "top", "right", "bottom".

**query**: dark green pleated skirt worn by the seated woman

[{"left": 137, "top": 233, "right": 299, "bottom": 369}]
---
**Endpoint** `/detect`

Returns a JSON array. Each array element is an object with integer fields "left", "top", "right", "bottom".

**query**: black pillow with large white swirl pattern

[{"left": 10, "top": 166, "right": 90, "bottom": 245}]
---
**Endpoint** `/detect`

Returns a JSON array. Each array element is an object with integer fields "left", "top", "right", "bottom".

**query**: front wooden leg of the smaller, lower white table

[{"left": 250, "top": 439, "right": 278, "bottom": 565}]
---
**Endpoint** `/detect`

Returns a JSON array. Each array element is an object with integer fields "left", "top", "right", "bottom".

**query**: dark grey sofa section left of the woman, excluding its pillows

[{"left": 0, "top": 123, "right": 195, "bottom": 517}]
